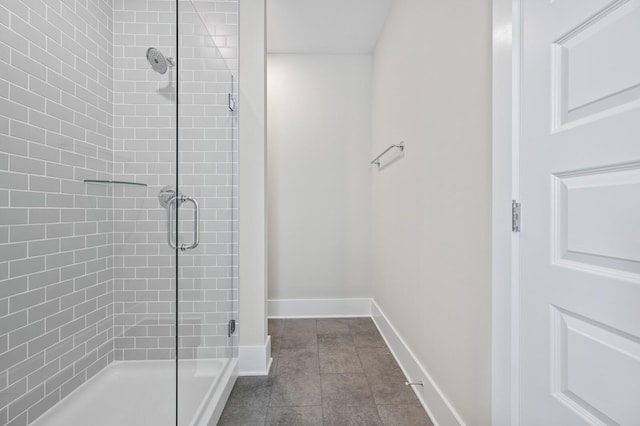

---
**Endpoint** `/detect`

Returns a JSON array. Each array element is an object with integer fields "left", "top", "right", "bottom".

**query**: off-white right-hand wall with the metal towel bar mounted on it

[{"left": 371, "top": 0, "right": 491, "bottom": 425}]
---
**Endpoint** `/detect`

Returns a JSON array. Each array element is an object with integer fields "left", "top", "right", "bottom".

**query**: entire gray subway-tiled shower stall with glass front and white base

[{"left": 0, "top": 0, "right": 238, "bottom": 426}]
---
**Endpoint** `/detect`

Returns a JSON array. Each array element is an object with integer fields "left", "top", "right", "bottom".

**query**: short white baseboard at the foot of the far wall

[{"left": 268, "top": 298, "right": 371, "bottom": 318}]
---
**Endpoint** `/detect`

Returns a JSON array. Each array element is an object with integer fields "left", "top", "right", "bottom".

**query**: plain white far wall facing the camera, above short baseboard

[{"left": 267, "top": 54, "right": 371, "bottom": 299}]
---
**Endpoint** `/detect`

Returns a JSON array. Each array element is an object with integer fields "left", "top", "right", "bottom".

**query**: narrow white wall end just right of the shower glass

[{"left": 239, "top": 0, "right": 271, "bottom": 372}]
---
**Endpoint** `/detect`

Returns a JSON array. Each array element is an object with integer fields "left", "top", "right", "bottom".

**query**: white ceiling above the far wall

[{"left": 267, "top": 0, "right": 393, "bottom": 54}]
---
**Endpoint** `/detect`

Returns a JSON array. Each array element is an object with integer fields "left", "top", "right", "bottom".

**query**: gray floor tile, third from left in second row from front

[{"left": 320, "top": 373, "right": 374, "bottom": 406}]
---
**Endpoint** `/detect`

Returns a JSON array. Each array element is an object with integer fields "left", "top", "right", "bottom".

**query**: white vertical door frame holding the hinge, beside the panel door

[{"left": 491, "top": 0, "right": 526, "bottom": 426}]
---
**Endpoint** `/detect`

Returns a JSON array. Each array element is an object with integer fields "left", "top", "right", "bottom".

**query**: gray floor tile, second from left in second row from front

[{"left": 269, "top": 372, "right": 322, "bottom": 407}]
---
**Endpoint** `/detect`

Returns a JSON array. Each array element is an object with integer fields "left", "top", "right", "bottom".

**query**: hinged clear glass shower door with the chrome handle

[{"left": 172, "top": 0, "right": 237, "bottom": 426}]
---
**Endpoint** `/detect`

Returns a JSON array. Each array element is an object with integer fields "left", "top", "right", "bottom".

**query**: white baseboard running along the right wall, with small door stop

[{"left": 371, "top": 300, "right": 464, "bottom": 426}]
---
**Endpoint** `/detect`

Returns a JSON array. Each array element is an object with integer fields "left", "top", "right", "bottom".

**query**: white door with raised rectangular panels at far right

[{"left": 519, "top": 0, "right": 640, "bottom": 426}]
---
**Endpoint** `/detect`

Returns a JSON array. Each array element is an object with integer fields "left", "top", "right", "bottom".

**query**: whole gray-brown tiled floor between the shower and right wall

[{"left": 218, "top": 318, "right": 433, "bottom": 426}]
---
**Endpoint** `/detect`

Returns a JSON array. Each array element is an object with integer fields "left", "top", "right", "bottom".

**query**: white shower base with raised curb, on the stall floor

[{"left": 31, "top": 359, "right": 237, "bottom": 426}]
